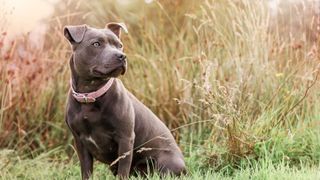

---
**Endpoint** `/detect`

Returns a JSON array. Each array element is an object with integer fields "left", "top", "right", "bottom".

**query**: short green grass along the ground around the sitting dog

[{"left": 0, "top": 149, "right": 320, "bottom": 180}]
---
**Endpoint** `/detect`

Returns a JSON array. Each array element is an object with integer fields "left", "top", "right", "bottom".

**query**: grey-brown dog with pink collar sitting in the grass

[{"left": 64, "top": 23, "right": 186, "bottom": 179}]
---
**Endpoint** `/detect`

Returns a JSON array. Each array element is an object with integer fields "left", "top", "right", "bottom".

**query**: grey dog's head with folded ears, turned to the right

[{"left": 64, "top": 23, "right": 127, "bottom": 79}]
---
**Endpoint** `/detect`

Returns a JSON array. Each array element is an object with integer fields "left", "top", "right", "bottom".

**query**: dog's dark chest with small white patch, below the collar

[{"left": 68, "top": 104, "right": 118, "bottom": 162}]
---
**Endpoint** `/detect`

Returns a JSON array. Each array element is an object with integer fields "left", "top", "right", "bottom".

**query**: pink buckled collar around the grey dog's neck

[{"left": 70, "top": 78, "right": 114, "bottom": 103}]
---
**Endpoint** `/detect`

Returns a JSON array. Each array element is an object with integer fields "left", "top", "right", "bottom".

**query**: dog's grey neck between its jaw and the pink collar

[{"left": 70, "top": 60, "right": 110, "bottom": 93}]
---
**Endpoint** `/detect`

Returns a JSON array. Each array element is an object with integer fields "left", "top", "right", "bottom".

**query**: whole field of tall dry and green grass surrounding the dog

[{"left": 0, "top": 0, "right": 320, "bottom": 180}]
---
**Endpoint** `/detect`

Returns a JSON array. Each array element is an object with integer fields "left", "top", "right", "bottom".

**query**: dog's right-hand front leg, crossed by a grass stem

[{"left": 118, "top": 131, "right": 135, "bottom": 179}]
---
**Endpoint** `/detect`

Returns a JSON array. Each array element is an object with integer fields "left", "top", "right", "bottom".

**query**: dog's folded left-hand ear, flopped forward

[{"left": 63, "top": 24, "right": 87, "bottom": 44}]
